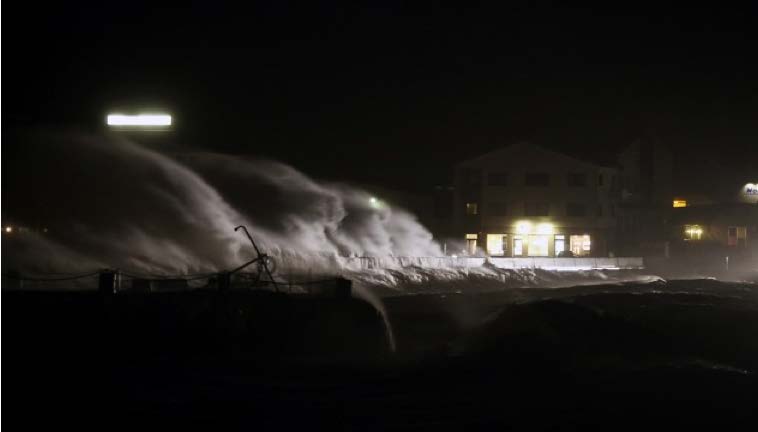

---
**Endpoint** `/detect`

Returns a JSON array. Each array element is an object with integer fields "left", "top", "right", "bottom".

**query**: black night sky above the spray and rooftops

[{"left": 2, "top": 1, "right": 758, "bottom": 189}]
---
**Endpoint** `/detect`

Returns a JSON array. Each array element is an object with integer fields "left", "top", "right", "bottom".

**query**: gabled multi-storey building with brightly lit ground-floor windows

[{"left": 453, "top": 143, "right": 619, "bottom": 257}]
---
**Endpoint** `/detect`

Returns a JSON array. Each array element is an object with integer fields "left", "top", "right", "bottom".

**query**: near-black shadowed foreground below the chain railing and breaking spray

[{"left": 2, "top": 281, "right": 758, "bottom": 430}]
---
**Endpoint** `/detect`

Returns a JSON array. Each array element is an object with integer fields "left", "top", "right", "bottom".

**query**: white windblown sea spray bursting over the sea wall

[{"left": 3, "top": 134, "right": 441, "bottom": 274}]
